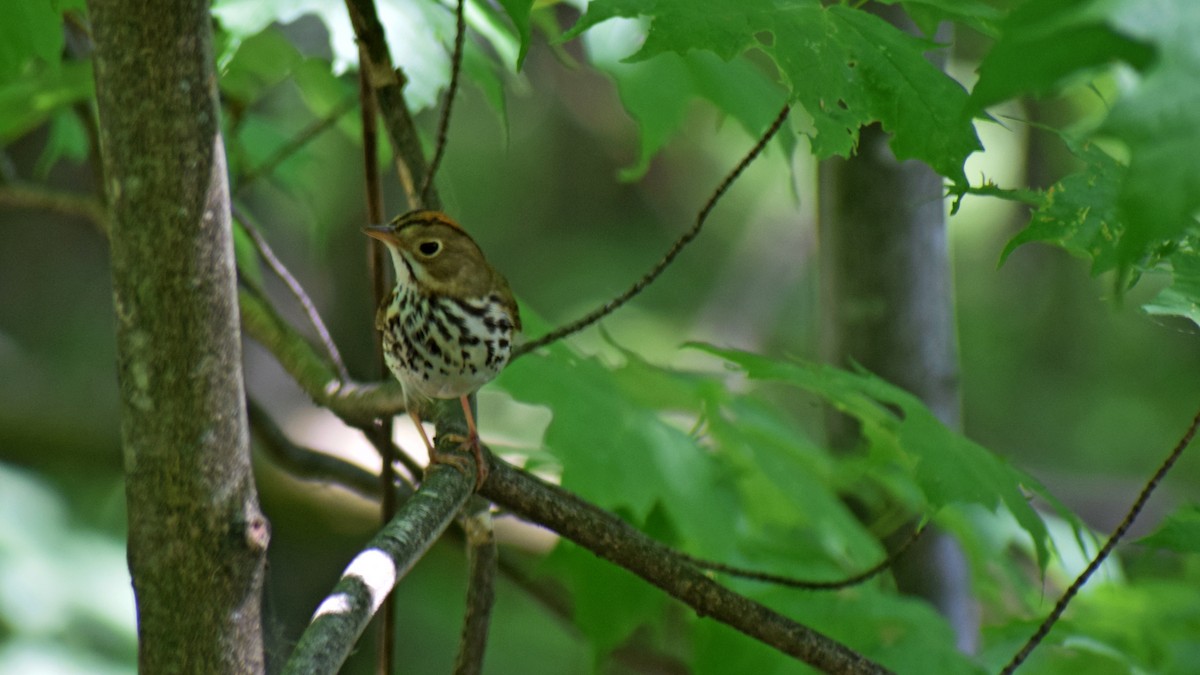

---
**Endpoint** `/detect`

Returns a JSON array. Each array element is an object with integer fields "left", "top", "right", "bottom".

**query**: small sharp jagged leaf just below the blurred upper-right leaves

[{"left": 1000, "top": 142, "right": 1127, "bottom": 275}]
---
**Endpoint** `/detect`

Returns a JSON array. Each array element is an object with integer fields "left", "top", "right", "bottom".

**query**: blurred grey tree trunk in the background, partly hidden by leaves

[{"left": 818, "top": 6, "right": 978, "bottom": 652}]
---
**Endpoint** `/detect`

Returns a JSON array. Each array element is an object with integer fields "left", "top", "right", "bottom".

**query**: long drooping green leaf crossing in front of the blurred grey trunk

[{"left": 690, "top": 344, "right": 1049, "bottom": 568}]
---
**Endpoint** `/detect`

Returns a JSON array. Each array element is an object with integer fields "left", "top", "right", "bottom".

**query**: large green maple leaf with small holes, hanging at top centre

[{"left": 566, "top": 0, "right": 980, "bottom": 185}]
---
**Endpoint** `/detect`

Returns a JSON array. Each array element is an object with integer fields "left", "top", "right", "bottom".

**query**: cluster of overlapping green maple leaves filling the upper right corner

[{"left": 972, "top": 0, "right": 1200, "bottom": 307}]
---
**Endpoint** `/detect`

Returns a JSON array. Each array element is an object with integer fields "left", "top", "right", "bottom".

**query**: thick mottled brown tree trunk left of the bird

[{"left": 89, "top": 0, "right": 268, "bottom": 674}]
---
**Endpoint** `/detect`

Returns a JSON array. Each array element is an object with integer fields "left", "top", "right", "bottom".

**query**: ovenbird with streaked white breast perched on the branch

[{"left": 364, "top": 210, "right": 521, "bottom": 488}]
